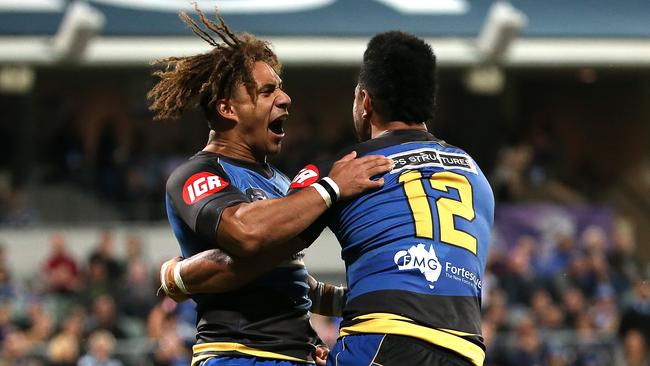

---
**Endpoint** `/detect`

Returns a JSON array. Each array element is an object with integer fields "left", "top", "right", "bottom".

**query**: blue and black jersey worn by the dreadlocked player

[{"left": 166, "top": 152, "right": 317, "bottom": 362}]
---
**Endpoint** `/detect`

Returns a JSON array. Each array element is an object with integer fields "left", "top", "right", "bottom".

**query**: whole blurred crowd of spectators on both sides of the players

[{"left": 0, "top": 220, "right": 650, "bottom": 366}]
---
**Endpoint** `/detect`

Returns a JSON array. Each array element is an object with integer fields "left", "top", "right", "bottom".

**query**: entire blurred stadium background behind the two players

[{"left": 0, "top": 0, "right": 650, "bottom": 366}]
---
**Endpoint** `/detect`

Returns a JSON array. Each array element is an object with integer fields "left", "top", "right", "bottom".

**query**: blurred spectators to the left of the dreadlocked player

[{"left": 0, "top": 231, "right": 195, "bottom": 366}]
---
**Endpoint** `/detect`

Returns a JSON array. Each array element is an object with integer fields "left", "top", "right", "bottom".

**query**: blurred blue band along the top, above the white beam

[{"left": 0, "top": 0, "right": 650, "bottom": 38}]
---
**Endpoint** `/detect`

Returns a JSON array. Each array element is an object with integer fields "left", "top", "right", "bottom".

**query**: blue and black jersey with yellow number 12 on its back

[{"left": 291, "top": 130, "right": 494, "bottom": 365}]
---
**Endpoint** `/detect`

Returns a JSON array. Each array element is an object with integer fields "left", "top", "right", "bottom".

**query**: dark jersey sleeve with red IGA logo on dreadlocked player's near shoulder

[{"left": 167, "top": 163, "right": 249, "bottom": 246}]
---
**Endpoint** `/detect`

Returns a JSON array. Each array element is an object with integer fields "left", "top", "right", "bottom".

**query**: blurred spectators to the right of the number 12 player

[{"left": 482, "top": 220, "right": 650, "bottom": 366}]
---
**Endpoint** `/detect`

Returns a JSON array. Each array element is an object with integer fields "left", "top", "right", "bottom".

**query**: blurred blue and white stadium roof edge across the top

[{"left": 0, "top": 0, "right": 650, "bottom": 66}]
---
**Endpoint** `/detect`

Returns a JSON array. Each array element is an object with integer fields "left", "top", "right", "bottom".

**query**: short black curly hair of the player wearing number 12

[{"left": 359, "top": 31, "right": 436, "bottom": 123}]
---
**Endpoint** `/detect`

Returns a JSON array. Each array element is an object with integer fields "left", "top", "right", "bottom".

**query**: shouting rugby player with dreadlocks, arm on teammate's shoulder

[{"left": 148, "top": 7, "right": 393, "bottom": 366}]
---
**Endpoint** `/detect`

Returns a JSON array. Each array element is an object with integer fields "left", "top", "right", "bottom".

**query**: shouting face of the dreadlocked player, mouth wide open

[{"left": 233, "top": 61, "right": 291, "bottom": 160}]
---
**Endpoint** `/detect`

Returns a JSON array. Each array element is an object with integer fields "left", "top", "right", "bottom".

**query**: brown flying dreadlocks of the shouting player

[{"left": 147, "top": 3, "right": 281, "bottom": 129}]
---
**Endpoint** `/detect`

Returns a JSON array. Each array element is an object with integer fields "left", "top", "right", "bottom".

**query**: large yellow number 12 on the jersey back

[{"left": 399, "top": 170, "right": 477, "bottom": 255}]
